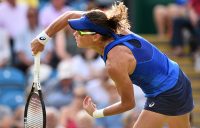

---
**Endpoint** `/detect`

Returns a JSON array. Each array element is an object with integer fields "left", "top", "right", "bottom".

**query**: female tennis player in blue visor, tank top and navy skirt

[{"left": 32, "top": 3, "right": 194, "bottom": 128}]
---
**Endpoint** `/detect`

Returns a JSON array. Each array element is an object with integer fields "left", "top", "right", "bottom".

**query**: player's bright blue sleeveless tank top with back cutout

[{"left": 102, "top": 33, "right": 179, "bottom": 97}]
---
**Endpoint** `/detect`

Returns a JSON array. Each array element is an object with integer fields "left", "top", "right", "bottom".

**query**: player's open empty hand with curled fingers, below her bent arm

[{"left": 83, "top": 96, "right": 97, "bottom": 116}]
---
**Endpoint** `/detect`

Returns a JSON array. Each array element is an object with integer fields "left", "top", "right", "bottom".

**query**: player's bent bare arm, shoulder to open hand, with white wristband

[{"left": 83, "top": 46, "right": 136, "bottom": 117}]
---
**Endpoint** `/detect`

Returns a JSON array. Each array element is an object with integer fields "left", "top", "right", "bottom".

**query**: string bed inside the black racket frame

[{"left": 27, "top": 94, "right": 43, "bottom": 128}]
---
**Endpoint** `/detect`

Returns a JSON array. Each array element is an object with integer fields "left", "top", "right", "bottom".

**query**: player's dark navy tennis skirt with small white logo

[{"left": 144, "top": 70, "right": 194, "bottom": 116}]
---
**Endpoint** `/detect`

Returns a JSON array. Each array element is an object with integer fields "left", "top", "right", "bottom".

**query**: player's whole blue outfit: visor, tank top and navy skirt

[{"left": 68, "top": 16, "right": 194, "bottom": 116}]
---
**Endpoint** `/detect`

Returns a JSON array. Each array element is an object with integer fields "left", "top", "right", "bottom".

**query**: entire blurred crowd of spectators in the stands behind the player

[{"left": 0, "top": 0, "right": 200, "bottom": 128}]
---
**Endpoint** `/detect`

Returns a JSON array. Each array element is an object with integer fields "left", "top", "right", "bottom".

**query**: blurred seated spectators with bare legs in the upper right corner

[{"left": 153, "top": 0, "right": 200, "bottom": 72}]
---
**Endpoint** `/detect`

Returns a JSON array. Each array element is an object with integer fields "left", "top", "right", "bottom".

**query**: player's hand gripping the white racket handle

[{"left": 31, "top": 38, "right": 44, "bottom": 55}]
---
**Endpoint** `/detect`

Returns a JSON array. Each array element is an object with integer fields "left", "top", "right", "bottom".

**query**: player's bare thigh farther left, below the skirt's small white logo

[{"left": 133, "top": 110, "right": 166, "bottom": 128}]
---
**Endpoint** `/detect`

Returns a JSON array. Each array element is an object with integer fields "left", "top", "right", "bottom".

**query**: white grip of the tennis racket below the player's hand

[{"left": 33, "top": 52, "right": 40, "bottom": 83}]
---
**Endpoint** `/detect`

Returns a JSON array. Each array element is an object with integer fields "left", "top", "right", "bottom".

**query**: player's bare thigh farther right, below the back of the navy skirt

[{"left": 168, "top": 113, "right": 191, "bottom": 128}]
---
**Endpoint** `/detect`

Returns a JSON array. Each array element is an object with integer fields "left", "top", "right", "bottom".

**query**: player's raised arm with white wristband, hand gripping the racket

[{"left": 31, "top": 11, "right": 85, "bottom": 55}]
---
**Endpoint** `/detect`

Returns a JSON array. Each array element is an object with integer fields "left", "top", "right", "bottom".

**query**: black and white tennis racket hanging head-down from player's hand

[{"left": 24, "top": 53, "right": 46, "bottom": 128}]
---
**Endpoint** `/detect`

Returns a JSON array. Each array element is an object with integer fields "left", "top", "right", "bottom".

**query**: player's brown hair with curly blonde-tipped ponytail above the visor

[{"left": 86, "top": 2, "right": 130, "bottom": 38}]
